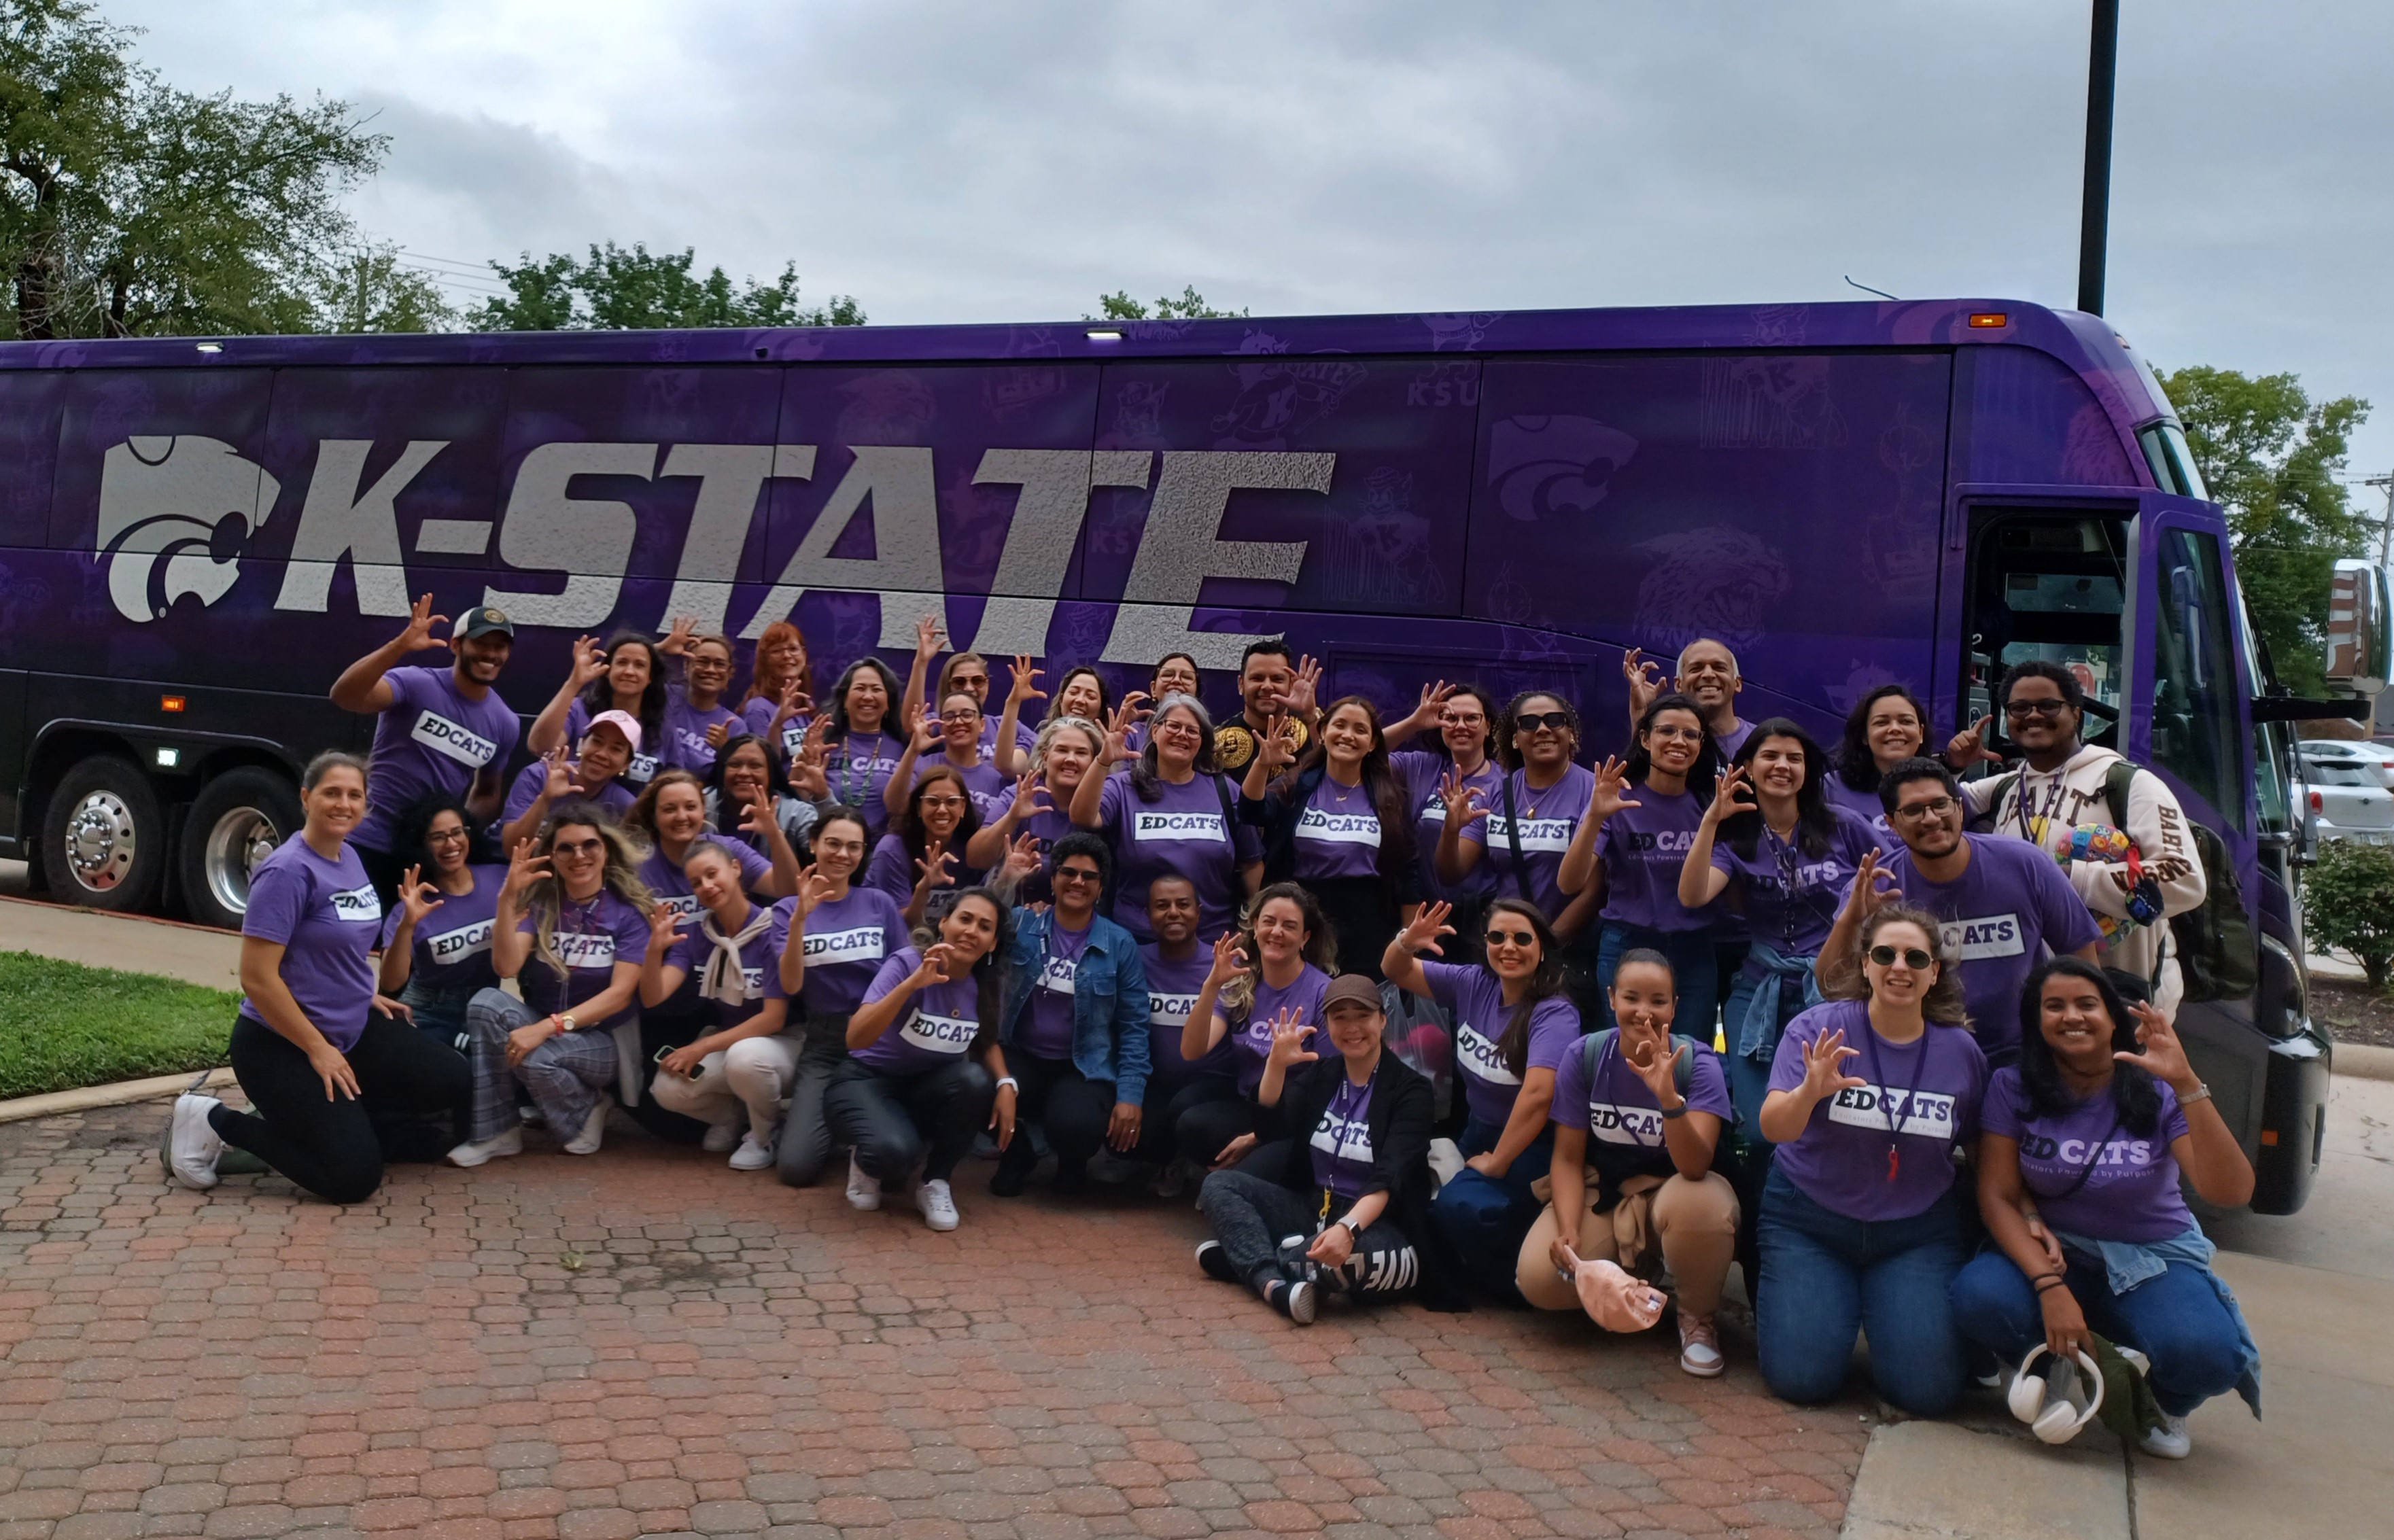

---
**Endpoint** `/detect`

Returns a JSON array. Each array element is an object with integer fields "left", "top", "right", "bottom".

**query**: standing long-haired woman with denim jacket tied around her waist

[{"left": 1678, "top": 716, "right": 1879, "bottom": 1123}]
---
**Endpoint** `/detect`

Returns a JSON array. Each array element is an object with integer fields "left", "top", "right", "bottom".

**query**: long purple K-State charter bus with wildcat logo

[{"left": 0, "top": 302, "right": 2344, "bottom": 1212}]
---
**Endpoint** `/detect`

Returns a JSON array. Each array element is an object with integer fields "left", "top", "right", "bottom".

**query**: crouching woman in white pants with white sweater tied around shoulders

[{"left": 639, "top": 841, "right": 797, "bottom": 1171}]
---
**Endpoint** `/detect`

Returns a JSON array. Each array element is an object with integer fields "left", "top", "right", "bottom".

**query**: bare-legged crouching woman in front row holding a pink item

[{"left": 1489, "top": 943, "right": 1738, "bottom": 1380}]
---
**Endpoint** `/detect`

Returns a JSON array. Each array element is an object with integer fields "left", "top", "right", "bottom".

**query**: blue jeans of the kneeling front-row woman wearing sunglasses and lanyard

[{"left": 1755, "top": 1166, "right": 1968, "bottom": 1418}]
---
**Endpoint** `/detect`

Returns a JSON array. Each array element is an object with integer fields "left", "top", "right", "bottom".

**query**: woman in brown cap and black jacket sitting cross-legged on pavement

[{"left": 1197, "top": 973, "right": 1432, "bottom": 1327}]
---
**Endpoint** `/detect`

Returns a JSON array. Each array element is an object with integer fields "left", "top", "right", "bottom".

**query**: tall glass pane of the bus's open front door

[{"left": 2152, "top": 529, "right": 2246, "bottom": 831}]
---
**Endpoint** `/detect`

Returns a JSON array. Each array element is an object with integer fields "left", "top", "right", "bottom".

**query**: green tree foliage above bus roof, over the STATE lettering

[{"left": 467, "top": 242, "right": 864, "bottom": 330}]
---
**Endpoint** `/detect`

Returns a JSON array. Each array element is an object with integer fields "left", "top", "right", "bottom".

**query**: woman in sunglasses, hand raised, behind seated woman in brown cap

[{"left": 1381, "top": 898, "right": 1580, "bottom": 1301}]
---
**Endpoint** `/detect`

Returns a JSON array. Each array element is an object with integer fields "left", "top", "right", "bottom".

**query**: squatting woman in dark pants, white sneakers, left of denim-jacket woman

[{"left": 824, "top": 888, "right": 1015, "bottom": 1231}]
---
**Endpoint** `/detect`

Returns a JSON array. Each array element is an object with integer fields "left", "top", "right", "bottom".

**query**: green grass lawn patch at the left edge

[{"left": 0, "top": 951, "right": 242, "bottom": 1100}]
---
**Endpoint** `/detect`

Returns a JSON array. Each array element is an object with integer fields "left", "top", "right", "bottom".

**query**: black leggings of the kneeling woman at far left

[{"left": 208, "top": 1013, "right": 474, "bottom": 1202}]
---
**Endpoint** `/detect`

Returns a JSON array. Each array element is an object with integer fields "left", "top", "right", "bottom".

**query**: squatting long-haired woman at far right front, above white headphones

[{"left": 1954, "top": 958, "right": 2257, "bottom": 1458}]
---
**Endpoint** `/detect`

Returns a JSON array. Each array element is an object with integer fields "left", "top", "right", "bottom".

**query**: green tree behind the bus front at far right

[{"left": 2162, "top": 364, "right": 2375, "bottom": 695}]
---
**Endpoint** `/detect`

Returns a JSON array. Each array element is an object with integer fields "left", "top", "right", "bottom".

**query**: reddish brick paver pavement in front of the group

[{"left": 0, "top": 1104, "right": 1870, "bottom": 1540}]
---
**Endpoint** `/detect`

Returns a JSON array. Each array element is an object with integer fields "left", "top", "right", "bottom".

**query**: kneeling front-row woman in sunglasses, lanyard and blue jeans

[{"left": 1755, "top": 903, "right": 1987, "bottom": 1418}]
